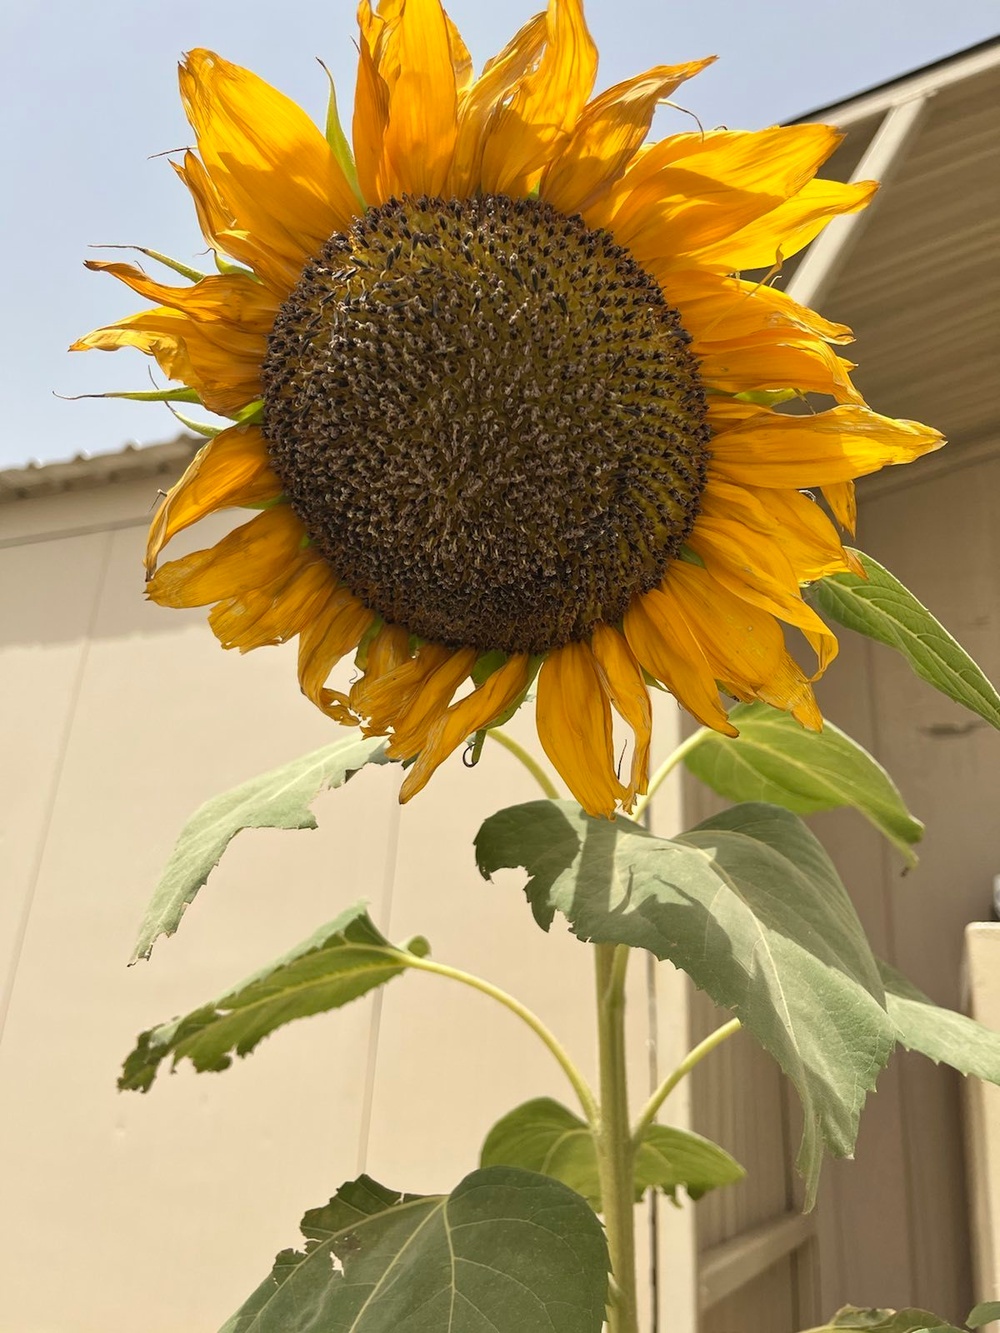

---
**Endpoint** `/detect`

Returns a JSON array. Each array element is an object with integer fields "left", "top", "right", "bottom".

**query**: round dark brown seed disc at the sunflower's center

[{"left": 264, "top": 195, "right": 709, "bottom": 653}]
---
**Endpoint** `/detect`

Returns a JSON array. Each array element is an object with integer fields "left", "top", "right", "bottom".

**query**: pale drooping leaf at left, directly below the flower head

[{"left": 132, "top": 732, "right": 388, "bottom": 962}]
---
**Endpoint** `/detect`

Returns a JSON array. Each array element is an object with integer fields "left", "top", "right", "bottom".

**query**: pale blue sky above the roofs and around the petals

[{"left": 0, "top": 0, "right": 997, "bottom": 468}]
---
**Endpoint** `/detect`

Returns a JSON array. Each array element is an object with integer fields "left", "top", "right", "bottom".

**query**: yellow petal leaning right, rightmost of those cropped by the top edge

[{"left": 480, "top": 0, "right": 597, "bottom": 197}]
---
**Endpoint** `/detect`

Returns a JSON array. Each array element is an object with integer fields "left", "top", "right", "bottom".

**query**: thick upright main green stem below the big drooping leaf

[{"left": 595, "top": 944, "right": 639, "bottom": 1333}]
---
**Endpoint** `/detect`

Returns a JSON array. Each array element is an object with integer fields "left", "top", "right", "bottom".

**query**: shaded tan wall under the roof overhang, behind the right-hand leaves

[{"left": 816, "top": 450, "right": 1000, "bottom": 1325}]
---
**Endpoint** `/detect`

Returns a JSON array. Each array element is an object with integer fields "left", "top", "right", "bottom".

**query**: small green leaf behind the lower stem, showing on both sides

[{"left": 480, "top": 1097, "right": 747, "bottom": 1212}]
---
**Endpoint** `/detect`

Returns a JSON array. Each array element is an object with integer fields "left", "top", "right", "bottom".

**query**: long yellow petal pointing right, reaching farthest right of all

[{"left": 708, "top": 403, "right": 944, "bottom": 489}]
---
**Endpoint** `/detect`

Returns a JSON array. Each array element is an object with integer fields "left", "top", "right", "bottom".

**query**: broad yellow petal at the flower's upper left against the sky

[{"left": 180, "top": 49, "right": 357, "bottom": 286}]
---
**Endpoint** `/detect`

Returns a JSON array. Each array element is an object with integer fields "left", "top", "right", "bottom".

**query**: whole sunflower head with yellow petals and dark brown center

[{"left": 73, "top": 0, "right": 943, "bottom": 814}]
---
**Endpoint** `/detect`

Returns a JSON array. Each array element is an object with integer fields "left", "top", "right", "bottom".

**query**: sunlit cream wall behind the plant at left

[{"left": 0, "top": 463, "right": 695, "bottom": 1333}]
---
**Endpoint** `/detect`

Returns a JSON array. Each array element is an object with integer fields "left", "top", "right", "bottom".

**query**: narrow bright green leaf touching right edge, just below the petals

[{"left": 812, "top": 551, "right": 1000, "bottom": 728}]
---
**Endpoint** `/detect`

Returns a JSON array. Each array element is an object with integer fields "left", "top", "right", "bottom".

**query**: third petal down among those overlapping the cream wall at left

[{"left": 208, "top": 555, "right": 336, "bottom": 653}]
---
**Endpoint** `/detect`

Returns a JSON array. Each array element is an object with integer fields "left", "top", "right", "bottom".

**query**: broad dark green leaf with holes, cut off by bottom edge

[{"left": 221, "top": 1166, "right": 608, "bottom": 1333}]
